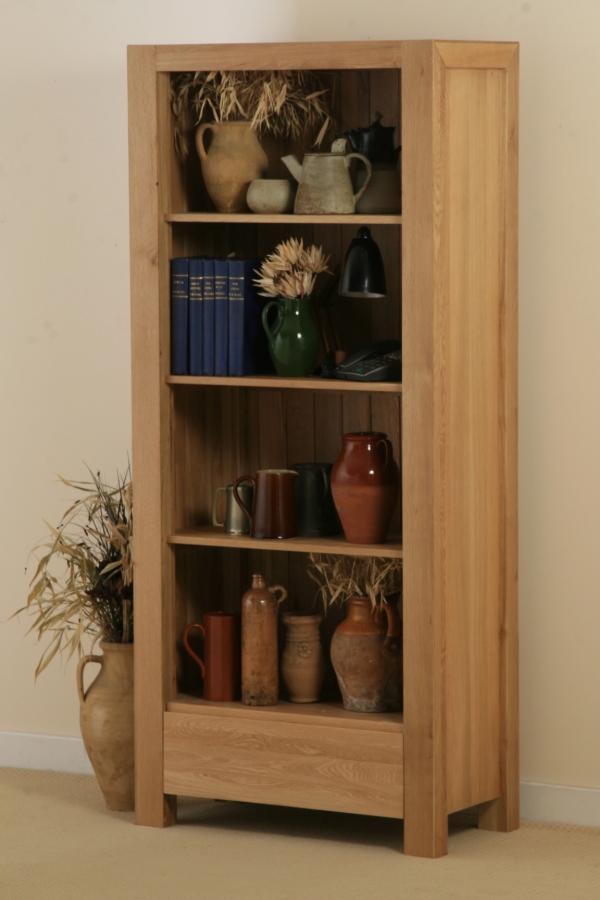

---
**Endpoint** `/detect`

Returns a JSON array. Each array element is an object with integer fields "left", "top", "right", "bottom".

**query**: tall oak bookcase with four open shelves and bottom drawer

[{"left": 129, "top": 41, "right": 519, "bottom": 857}]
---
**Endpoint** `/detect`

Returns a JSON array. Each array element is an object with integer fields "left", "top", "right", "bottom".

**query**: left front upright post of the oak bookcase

[{"left": 128, "top": 47, "right": 175, "bottom": 826}]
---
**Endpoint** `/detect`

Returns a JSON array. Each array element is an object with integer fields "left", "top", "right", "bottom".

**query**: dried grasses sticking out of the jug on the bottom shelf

[{"left": 308, "top": 553, "right": 402, "bottom": 608}]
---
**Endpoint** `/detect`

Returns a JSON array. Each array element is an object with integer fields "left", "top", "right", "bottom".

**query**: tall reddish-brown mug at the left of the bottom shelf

[{"left": 183, "top": 612, "right": 242, "bottom": 701}]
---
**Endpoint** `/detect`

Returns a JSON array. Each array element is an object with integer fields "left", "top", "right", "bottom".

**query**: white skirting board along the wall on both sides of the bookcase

[{"left": 0, "top": 731, "right": 600, "bottom": 828}]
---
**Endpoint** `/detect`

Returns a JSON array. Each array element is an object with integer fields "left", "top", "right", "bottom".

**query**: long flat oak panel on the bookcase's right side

[{"left": 436, "top": 49, "right": 508, "bottom": 824}]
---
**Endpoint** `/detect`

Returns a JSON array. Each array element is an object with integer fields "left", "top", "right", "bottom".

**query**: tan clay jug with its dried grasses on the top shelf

[{"left": 171, "top": 71, "right": 332, "bottom": 213}]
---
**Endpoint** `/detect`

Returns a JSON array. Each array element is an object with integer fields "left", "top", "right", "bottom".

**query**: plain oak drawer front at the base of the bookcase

[{"left": 164, "top": 713, "right": 403, "bottom": 818}]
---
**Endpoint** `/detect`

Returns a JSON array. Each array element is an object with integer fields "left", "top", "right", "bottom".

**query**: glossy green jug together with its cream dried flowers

[{"left": 254, "top": 238, "right": 329, "bottom": 377}]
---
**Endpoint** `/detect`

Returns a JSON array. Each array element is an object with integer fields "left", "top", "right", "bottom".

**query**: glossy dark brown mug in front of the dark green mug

[{"left": 233, "top": 469, "right": 298, "bottom": 538}]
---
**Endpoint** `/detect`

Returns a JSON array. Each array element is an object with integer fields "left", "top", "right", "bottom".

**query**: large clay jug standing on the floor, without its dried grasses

[{"left": 77, "top": 641, "right": 135, "bottom": 811}]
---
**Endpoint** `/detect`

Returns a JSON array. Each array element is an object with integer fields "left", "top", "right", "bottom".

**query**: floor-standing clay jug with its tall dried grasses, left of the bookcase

[{"left": 15, "top": 469, "right": 134, "bottom": 810}]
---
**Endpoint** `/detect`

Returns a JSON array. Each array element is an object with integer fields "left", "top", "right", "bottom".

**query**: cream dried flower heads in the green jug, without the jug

[{"left": 254, "top": 238, "right": 329, "bottom": 300}]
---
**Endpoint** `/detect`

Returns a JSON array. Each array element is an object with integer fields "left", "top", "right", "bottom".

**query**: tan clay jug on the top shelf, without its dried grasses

[{"left": 196, "top": 122, "right": 268, "bottom": 213}]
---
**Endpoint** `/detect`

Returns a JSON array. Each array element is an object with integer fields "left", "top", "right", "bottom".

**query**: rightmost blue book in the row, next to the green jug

[{"left": 228, "top": 259, "right": 274, "bottom": 375}]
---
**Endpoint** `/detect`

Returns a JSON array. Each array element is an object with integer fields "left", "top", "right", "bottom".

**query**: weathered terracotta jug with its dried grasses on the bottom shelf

[{"left": 308, "top": 553, "right": 402, "bottom": 712}]
